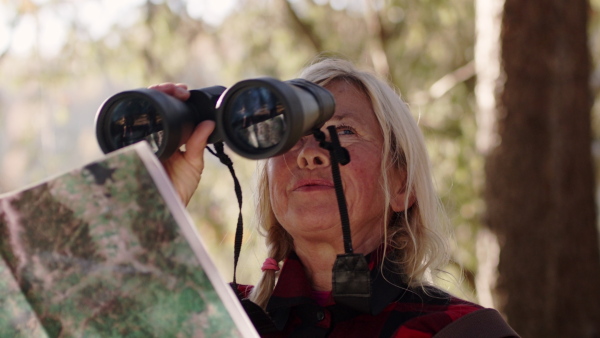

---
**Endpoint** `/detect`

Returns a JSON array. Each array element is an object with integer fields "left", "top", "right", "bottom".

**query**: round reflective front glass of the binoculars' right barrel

[{"left": 230, "top": 87, "right": 286, "bottom": 150}]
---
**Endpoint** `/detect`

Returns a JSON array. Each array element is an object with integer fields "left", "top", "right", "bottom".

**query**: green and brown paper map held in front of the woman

[{"left": 0, "top": 145, "right": 251, "bottom": 337}]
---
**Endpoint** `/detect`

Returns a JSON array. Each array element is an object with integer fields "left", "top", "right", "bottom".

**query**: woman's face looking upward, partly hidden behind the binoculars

[{"left": 267, "top": 81, "right": 403, "bottom": 253}]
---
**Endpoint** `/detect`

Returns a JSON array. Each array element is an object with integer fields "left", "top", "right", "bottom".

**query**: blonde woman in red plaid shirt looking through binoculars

[{"left": 152, "top": 59, "right": 516, "bottom": 337}]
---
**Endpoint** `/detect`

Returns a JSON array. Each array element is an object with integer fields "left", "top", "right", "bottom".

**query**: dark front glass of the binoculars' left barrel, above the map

[{"left": 108, "top": 98, "right": 164, "bottom": 152}]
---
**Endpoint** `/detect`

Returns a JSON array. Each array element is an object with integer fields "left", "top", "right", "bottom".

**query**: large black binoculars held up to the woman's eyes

[{"left": 96, "top": 77, "right": 335, "bottom": 160}]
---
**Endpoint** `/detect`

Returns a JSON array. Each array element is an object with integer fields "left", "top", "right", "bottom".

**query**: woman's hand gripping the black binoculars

[{"left": 149, "top": 83, "right": 215, "bottom": 205}]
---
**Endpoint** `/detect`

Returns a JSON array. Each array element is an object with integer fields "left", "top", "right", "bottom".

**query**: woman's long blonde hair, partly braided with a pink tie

[{"left": 250, "top": 59, "right": 449, "bottom": 307}]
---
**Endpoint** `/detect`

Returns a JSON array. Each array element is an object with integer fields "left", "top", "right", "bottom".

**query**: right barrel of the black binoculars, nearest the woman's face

[{"left": 216, "top": 78, "right": 335, "bottom": 159}]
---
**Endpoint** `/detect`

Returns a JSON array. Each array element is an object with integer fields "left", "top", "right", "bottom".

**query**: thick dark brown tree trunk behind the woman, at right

[{"left": 485, "top": 0, "right": 600, "bottom": 337}]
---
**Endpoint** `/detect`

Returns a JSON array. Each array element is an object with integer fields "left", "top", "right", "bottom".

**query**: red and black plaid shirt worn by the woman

[{"left": 238, "top": 253, "right": 482, "bottom": 338}]
